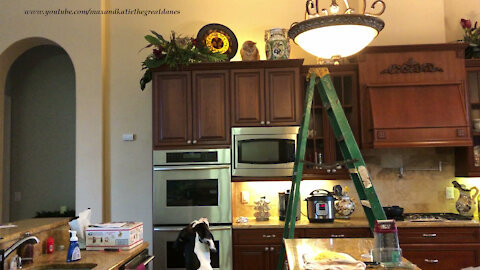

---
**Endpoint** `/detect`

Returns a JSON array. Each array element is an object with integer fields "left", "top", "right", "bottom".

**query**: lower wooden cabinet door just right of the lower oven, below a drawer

[{"left": 233, "top": 245, "right": 271, "bottom": 270}]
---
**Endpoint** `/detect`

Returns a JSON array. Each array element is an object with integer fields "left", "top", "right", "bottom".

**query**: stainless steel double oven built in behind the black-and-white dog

[{"left": 153, "top": 149, "right": 232, "bottom": 270}]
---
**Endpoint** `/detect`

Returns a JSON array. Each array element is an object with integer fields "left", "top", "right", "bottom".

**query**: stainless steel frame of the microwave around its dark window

[{"left": 232, "top": 126, "right": 299, "bottom": 177}]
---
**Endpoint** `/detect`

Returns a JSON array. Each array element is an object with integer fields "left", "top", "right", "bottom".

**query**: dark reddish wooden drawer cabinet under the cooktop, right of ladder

[{"left": 398, "top": 227, "right": 480, "bottom": 270}]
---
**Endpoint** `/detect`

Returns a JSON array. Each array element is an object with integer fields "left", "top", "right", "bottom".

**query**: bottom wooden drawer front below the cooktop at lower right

[{"left": 401, "top": 244, "right": 480, "bottom": 270}]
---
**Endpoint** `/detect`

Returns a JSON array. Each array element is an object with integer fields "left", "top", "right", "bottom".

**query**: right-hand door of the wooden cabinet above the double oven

[{"left": 192, "top": 71, "right": 230, "bottom": 145}]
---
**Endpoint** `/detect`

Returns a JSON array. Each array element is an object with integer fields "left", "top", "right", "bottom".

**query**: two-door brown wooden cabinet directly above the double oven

[{"left": 153, "top": 70, "right": 230, "bottom": 150}]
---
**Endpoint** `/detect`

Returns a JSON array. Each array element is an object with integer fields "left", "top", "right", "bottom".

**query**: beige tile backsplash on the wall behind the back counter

[{"left": 232, "top": 148, "right": 480, "bottom": 218}]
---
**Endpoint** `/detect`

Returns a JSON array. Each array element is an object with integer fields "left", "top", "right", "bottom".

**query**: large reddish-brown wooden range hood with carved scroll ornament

[{"left": 359, "top": 43, "right": 472, "bottom": 148}]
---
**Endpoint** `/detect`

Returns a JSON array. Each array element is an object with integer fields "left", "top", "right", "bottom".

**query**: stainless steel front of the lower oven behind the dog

[{"left": 153, "top": 226, "right": 233, "bottom": 270}]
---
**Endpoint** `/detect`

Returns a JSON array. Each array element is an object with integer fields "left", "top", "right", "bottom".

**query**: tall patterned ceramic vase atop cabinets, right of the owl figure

[{"left": 265, "top": 28, "right": 290, "bottom": 60}]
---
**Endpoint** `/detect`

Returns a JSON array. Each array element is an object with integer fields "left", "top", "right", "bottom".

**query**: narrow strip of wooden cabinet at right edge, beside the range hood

[{"left": 455, "top": 59, "right": 480, "bottom": 177}]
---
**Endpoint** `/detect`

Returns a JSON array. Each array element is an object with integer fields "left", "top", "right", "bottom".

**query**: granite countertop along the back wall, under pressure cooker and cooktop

[{"left": 232, "top": 216, "right": 480, "bottom": 229}]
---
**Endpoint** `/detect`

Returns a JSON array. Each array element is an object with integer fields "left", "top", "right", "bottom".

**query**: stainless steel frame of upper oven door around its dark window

[{"left": 153, "top": 165, "right": 232, "bottom": 225}]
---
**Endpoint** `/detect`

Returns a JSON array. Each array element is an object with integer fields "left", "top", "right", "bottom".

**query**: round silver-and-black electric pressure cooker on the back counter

[{"left": 305, "top": 189, "right": 335, "bottom": 222}]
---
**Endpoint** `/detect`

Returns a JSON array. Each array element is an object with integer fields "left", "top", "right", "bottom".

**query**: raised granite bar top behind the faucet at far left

[{"left": 0, "top": 218, "right": 70, "bottom": 244}]
